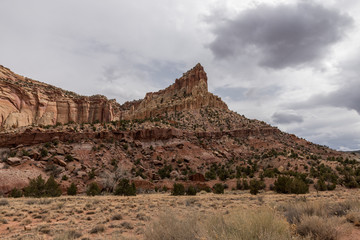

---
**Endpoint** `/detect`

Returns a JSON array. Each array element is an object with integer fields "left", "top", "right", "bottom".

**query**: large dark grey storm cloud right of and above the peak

[{"left": 209, "top": 2, "right": 353, "bottom": 69}]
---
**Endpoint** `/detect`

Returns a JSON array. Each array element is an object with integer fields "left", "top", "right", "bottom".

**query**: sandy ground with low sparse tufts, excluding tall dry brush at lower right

[{"left": 0, "top": 190, "right": 360, "bottom": 240}]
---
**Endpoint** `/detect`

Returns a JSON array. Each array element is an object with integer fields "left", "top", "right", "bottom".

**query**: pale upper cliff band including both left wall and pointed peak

[{"left": 0, "top": 64, "right": 228, "bottom": 129}]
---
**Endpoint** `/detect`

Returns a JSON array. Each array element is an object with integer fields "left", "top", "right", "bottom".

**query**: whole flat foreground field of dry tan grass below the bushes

[{"left": 0, "top": 190, "right": 360, "bottom": 240}]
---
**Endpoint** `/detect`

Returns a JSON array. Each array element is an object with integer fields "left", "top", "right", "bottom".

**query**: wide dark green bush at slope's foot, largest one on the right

[{"left": 274, "top": 176, "right": 309, "bottom": 194}]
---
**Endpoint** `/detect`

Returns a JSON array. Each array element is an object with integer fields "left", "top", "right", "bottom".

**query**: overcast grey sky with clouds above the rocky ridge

[{"left": 0, "top": 0, "right": 360, "bottom": 150}]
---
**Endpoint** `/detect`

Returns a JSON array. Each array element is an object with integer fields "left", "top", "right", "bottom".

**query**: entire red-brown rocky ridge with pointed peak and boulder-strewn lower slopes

[{"left": 0, "top": 64, "right": 360, "bottom": 194}]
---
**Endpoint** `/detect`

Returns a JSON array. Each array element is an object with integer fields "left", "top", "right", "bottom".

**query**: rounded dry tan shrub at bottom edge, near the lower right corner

[{"left": 296, "top": 216, "right": 341, "bottom": 240}]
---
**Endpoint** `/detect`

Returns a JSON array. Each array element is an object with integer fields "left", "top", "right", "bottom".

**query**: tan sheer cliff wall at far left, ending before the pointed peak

[{"left": 0, "top": 67, "right": 119, "bottom": 129}]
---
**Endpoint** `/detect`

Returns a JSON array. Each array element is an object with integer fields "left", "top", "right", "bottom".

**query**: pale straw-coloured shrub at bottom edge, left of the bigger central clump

[{"left": 145, "top": 212, "right": 199, "bottom": 240}]
